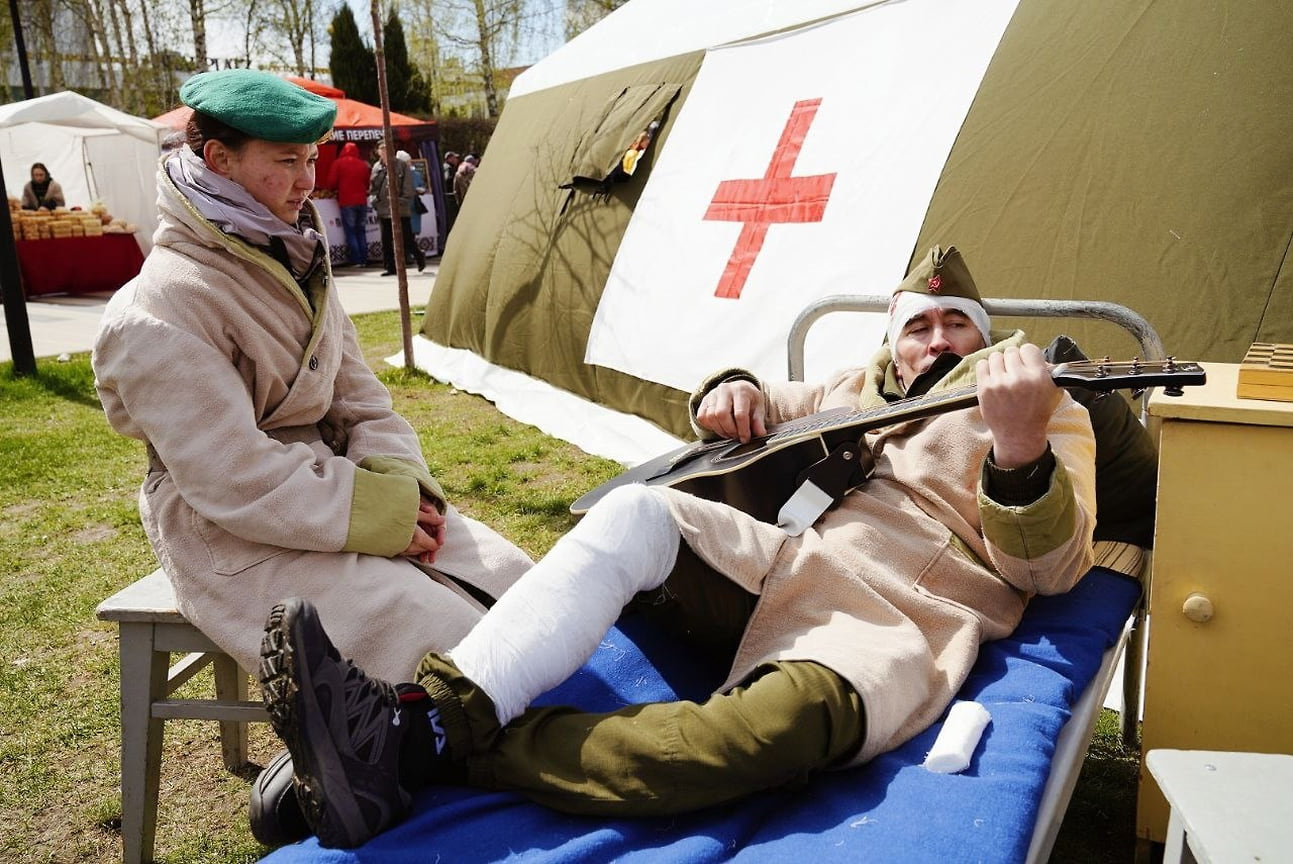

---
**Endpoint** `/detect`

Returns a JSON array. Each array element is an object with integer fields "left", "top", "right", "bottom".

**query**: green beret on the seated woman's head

[{"left": 180, "top": 69, "right": 336, "bottom": 144}]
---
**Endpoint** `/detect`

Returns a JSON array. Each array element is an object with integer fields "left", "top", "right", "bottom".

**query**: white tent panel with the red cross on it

[{"left": 584, "top": 0, "right": 1015, "bottom": 392}]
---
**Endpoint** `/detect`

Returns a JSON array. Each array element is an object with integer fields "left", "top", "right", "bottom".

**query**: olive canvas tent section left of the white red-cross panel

[{"left": 423, "top": 53, "right": 702, "bottom": 435}]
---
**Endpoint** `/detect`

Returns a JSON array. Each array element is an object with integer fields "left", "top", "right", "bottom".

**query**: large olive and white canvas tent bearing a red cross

[{"left": 416, "top": 0, "right": 1293, "bottom": 462}]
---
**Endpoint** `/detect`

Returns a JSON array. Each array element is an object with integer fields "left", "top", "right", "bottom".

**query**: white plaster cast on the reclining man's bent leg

[{"left": 449, "top": 485, "right": 681, "bottom": 723}]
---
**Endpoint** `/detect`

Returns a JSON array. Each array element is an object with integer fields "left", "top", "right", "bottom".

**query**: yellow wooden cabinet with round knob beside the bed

[{"left": 1137, "top": 363, "right": 1293, "bottom": 842}]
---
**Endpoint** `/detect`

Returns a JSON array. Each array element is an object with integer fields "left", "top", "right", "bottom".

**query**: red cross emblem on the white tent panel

[{"left": 705, "top": 98, "right": 835, "bottom": 299}]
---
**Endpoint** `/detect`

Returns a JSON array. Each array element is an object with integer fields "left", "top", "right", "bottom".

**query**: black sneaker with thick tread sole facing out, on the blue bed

[{"left": 260, "top": 599, "right": 433, "bottom": 848}]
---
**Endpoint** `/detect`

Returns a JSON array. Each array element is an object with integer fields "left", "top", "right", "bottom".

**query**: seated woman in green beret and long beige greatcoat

[{"left": 92, "top": 70, "right": 530, "bottom": 845}]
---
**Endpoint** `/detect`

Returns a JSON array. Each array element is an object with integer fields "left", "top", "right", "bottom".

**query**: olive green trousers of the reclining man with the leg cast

[{"left": 416, "top": 545, "right": 866, "bottom": 816}]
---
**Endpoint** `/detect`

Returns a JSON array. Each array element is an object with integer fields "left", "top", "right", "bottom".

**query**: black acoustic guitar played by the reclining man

[{"left": 570, "top": 357, "right": 1206, "bottom": 524}]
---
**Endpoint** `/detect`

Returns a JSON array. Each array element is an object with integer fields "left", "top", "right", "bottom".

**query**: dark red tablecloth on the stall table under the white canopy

[{"left": 16, "top": 234, "right": 144, "bottom": 297}]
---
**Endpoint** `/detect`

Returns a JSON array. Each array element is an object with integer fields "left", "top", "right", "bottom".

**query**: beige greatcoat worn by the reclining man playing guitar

[{"left": 663, "top": 331, "right": 1095, "bottom": 763}]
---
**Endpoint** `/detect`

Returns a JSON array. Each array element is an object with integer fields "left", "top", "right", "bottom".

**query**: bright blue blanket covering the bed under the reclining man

[{"left": 265, "top": 568, "right": 1139, "bottom": 864}]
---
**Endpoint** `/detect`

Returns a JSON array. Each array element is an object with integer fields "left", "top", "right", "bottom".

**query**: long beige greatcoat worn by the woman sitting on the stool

[{"left": 93, "top": 158, "right": 530, "bottom": 680}]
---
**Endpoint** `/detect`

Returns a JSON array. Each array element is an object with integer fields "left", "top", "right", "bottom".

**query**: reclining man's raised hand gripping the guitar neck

[{"left": 975, "top": 344, "right": 1059, "bottom": 468}]
